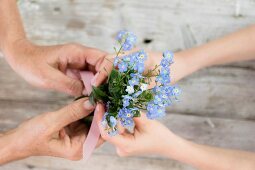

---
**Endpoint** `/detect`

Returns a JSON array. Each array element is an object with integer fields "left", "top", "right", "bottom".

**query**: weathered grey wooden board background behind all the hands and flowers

[{"left": 0, "top": 0, "right": 255, "bottom": 170}]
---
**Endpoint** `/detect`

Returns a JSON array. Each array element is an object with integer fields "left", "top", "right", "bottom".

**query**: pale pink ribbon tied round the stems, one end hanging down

[{"left": 80, "top": 71, "right": 100, "bottom": 161}]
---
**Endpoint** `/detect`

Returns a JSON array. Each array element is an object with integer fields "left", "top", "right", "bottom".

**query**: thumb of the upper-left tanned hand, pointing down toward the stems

[{"left": 47, "top": 67, "right": 83, "bottom": 96}]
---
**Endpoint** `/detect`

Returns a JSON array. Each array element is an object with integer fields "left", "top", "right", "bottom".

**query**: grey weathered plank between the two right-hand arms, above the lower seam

[{"left": 169, "top": 67, "right": 255, "bottom": 119}]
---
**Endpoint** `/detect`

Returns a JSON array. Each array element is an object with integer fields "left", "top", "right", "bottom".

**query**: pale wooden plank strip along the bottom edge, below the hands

[{"left": 0, "top": 154, "right": 193, "bottom": 170}]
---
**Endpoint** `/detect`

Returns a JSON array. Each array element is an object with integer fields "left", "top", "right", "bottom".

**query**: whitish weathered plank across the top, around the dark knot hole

[{"left": 17, "top": 0, "right": 255, "bottom": 51}]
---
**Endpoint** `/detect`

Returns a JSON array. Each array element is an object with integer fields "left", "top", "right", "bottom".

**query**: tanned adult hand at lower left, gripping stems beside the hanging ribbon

[{"left": 0, "top": 99, "right": 102, "bottom": 164}]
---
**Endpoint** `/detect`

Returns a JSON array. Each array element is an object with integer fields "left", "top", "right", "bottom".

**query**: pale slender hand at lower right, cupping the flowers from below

[{"left": 95, "top": 104, "right": 179, "bottom": 156}]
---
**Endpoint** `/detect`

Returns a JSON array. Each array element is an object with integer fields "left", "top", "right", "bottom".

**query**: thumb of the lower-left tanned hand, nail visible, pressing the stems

[{"left": 47, "top": 99, "right": 95, "bottom": 131}]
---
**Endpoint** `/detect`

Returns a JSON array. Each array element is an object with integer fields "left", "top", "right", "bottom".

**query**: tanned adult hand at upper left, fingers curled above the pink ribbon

[{"left": 5, "top": 40, "right": 106, "bottom": 96}]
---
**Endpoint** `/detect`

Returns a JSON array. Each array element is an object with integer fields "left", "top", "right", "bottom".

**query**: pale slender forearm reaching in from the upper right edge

[{"left": 176, "top": 26, "right": 255, "bottom": 71}]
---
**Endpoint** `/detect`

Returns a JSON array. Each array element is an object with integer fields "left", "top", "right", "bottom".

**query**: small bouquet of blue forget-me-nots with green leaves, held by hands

[{"left": 89, "top": 31, "right": 180, "bottom": 135}]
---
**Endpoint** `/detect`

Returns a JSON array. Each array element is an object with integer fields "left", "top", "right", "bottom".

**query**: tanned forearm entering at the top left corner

[{"left": 0, "top": 0, "right": 26, "bottom": 60}]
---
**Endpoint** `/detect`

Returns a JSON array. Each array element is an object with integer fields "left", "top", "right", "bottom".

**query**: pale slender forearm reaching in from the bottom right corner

[{"left": 161, "top": 137, "right": 255, "bottom": 170}]
